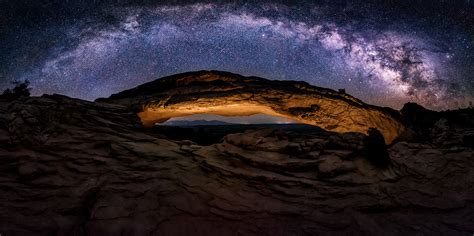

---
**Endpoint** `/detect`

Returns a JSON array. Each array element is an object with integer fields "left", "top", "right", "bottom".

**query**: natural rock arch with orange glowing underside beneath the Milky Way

[{"left": 97, "top": 71, "right": 406, "bottom": 143}]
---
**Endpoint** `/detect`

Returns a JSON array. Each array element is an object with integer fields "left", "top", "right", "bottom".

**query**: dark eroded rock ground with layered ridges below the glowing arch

[{"left": 0, "top": 96, "right": 474, "bottom": 236}]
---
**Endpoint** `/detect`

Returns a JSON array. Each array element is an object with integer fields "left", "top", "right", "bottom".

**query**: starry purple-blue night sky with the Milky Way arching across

[{"left": 0, "top": 0, "right": 474, "bottom": 110}]
